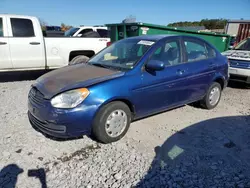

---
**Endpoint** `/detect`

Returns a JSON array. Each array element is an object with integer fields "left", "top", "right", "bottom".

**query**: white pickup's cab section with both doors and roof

[{"left": 0, "top": 15, "right": 45, "bottom": 69}]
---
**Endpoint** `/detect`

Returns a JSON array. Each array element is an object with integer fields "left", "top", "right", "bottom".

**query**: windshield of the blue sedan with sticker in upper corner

[{"left": 88, "top": 39, "right": 154, "bottom": 71}]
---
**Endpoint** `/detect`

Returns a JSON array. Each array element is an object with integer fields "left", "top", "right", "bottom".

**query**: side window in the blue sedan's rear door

[{"left": 184, "top": 40, "right": 208, "bottom": 62}]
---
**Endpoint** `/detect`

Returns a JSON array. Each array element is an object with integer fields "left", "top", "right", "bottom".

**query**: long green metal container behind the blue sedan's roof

[{"left": 106, "top": 23, "right": 231, "bottom": 52}]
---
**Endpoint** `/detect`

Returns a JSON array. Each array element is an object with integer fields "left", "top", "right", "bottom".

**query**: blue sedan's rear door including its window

[{"left": 183, "top": 37, "right": 216, "bottom": 100}]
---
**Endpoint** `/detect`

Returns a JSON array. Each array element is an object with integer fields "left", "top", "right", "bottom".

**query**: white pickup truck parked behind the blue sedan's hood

[{"left": 0, "top": 14, "right": 110, "bottom": 72}]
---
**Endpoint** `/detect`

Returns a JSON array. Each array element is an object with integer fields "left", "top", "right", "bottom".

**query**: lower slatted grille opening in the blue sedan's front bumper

[{"left": 28, "top": 112, "right": 66, "bottom": 133}]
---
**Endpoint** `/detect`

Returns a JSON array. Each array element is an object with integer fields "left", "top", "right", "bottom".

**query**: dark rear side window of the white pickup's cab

[{"left": 10, "top": 18, "right": 35, "bottom": 37}]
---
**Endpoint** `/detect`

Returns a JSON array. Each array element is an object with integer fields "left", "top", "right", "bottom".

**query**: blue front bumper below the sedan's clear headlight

[{"left": 28, "top": 97, "right": 97, "bottom": 138}]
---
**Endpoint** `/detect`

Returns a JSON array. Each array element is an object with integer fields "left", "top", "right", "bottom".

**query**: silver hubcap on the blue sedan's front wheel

[{"left": 105, "top": 110, "right": 128, "bottom": 137}]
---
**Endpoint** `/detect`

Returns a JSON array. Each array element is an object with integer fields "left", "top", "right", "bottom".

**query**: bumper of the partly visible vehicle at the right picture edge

[{"left": 229, "top": 67, "right": 250, "bottom": 84}]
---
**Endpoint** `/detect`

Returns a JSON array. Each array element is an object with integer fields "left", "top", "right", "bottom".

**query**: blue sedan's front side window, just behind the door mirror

[{"left": 151, "top": 41, "right": 181, "bottom": 66}]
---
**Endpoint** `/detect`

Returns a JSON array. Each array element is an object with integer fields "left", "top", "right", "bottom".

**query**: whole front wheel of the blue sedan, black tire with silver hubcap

[{"left": 92, "top": 101, "right": 131, "bottom": 144}]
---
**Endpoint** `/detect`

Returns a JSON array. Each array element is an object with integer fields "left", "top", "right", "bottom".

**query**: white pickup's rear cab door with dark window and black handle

[{"left": 7, "top": 17, "right": 45, "bottom": 69}]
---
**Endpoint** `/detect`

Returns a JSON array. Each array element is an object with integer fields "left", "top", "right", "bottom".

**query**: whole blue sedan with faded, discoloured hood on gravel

[{"left": 28, "top": 35, "right": 228, "bottom": 143}]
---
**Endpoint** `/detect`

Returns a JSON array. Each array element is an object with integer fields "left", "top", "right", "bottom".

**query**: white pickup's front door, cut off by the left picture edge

[{"left": 0, "top": 16, "right": 13, "bottom": 69}]
